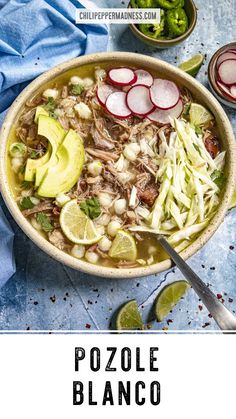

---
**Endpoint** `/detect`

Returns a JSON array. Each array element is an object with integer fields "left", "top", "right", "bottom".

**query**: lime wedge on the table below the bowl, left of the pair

[{"left": 116, "top": 300, "right": 144, "bottom": 330}]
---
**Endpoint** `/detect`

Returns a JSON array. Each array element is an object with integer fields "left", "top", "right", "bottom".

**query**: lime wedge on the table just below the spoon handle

[{"left": 154, "top": 281, "right": 190, "bottom": 322}]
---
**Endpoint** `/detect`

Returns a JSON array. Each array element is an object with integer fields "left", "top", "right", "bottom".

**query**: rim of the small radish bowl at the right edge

[{"left": 207, "top": 41, "right": 236, "bottom": 108}]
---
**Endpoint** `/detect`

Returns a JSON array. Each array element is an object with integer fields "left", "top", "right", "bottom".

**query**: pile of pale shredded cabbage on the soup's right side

[{"left": 141, "top": 119, "right": 225, "bottom": 251}]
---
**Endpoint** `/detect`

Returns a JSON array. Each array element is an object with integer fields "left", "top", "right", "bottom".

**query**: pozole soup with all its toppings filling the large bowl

[{"left": 7, "top": 63, "right": 224, "bottom": 268}]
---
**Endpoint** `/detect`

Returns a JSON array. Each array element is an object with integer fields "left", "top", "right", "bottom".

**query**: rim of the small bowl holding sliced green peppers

[{"left": 127, "top": 0, "right": 197, "bottom": 47}]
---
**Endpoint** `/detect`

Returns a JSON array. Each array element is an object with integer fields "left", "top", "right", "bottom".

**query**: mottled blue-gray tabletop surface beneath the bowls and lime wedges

[{"left": 0, "top": 0, "right": 236, "bottom": 330}]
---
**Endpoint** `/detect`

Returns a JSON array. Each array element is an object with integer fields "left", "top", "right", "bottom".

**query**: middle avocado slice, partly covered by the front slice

[{"left": 35, "top": 115, "right": 66, "bottom": 188}]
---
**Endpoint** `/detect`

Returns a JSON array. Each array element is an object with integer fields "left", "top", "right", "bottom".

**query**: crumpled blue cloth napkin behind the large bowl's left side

[{"left": 0, "top": 0, "right": 108, "bottom": 286}]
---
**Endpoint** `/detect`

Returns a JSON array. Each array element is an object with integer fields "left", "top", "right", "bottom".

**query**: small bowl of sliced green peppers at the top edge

[{"left": 128, "top": 0, "right": 197, "bottom": 49}]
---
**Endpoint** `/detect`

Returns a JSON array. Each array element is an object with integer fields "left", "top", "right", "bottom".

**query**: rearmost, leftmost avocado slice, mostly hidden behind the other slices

[{"left": 25, "top": 106, "right": 52, "bottom": 182}]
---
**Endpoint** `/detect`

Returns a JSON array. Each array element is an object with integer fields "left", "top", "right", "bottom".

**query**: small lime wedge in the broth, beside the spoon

[{"left": 109, "top": 230, "right": 137, "bottom": 261}]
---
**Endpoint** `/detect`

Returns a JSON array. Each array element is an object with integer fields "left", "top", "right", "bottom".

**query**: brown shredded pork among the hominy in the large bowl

[{"left": 12, "top": 65, "right": 219, "bottom": 269}]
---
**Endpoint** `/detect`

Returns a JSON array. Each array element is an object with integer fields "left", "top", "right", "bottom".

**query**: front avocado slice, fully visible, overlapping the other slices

[{"left": 38, "top": 130, "right": 85, "bottom": 198}]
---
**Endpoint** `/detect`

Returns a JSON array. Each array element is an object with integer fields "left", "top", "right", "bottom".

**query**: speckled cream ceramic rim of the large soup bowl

[{"left": 0, "top": 52, "right": 236, "bottom": 278}]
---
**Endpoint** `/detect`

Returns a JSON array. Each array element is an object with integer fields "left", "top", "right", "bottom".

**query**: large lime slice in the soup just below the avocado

[{"left": 60, "top": 199, "right": 101, "bottom": 245}]
